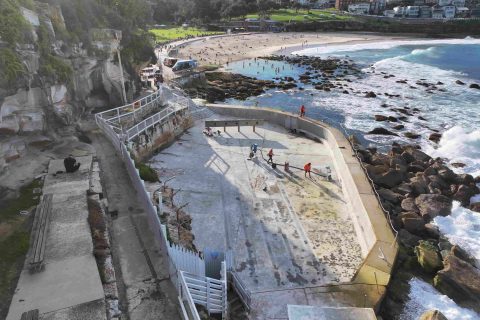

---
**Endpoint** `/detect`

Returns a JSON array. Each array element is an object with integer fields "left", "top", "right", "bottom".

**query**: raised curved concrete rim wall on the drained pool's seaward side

[{"left": 207, "top": 104, "right": 398, "bottom": 292}]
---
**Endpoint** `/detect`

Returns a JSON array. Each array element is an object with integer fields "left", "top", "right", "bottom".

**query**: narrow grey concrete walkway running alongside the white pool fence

[{"left": 89, "top": 128, "right": 180, "bottom": 320}]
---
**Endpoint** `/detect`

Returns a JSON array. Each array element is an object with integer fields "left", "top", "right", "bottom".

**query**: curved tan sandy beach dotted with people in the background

[{"left": 174, "top": 32, "right": 412, "bottom": 65}]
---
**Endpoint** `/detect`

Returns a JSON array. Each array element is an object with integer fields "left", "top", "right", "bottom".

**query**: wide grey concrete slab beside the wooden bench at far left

[{"left": 7, "top": 156, "right": 106, "bottom": 320}]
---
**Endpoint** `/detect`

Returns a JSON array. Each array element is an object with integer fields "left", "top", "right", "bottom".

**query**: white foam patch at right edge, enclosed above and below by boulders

[{"left": 433, "top": 201, "right": 480, "bottom": 267}]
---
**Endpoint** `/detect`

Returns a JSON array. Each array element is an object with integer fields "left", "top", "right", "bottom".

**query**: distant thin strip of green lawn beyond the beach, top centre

[{"left": 246, "top": 9, "right": 352, "bottom": 22}]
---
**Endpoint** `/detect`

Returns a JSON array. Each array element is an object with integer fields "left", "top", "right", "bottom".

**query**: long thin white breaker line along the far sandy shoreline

[{"left": 292, "top": 37, "right": 480, "bottom": 56}]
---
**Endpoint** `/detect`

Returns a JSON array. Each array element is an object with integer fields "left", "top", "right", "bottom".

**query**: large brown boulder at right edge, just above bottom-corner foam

[{"left": 433, "top": 254, "right": 480, "bottom": 312}]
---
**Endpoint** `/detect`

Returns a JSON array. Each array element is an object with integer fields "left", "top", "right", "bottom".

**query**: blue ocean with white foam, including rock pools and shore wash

[{"left": 226, "top": 38, "right": 480, "bottom": 320}]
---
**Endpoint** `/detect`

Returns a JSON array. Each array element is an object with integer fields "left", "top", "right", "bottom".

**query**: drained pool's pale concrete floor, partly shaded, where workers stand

[{"left": 152, "top": 117, "right": 362, "bottom": 293}]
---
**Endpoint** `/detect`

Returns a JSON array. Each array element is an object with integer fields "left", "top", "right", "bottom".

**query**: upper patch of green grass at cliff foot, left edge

[{"left": 0, "top": 180, "right": 42, "bottom": 223}]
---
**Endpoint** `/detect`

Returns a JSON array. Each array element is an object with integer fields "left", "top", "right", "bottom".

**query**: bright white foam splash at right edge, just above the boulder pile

[{"left": 426, "top": 127, "right": 480, "bottom": 177}]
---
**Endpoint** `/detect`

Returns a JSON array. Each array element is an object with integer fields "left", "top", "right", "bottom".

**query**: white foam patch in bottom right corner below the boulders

[{"left": 400, "top": 278, "right": 480, "bottom": 320}]
